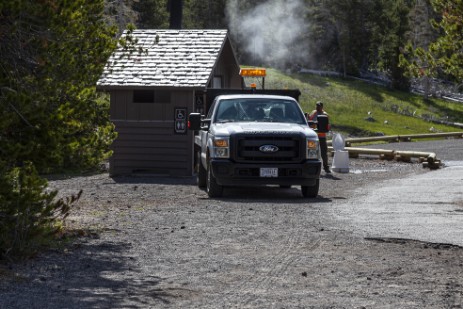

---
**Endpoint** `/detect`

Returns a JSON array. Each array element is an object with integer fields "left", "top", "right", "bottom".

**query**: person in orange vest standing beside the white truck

[{"left": 308, "top": 101, "right": 331, "bottom": 174}]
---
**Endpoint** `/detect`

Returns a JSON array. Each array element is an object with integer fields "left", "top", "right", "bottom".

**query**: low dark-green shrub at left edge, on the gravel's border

[{"left": 0, "top": 162, "right": 82, "bottom": 259}]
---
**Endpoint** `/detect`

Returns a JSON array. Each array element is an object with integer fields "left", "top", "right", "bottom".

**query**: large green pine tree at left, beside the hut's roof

[{"left": 0, "top": 0, "right": 116, "bottom": 172}]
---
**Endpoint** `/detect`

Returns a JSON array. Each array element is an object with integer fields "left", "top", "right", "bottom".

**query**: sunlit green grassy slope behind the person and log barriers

[{"left": 265, "top": 69, "right": 463, "bottom": 136}]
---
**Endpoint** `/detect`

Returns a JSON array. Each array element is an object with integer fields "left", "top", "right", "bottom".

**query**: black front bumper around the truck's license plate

[{"left": 211, "top": 159, "right": 322, "bottom": 186}]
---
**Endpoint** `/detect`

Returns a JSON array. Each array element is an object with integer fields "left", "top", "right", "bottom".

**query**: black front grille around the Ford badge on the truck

[{"left": 232, "top": 135, "right": 306, "bottom": 163}]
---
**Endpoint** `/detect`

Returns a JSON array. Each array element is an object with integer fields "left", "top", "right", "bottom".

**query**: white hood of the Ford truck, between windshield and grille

[{"left": 211, "top": 122, "right": 317, "bottom": 138}]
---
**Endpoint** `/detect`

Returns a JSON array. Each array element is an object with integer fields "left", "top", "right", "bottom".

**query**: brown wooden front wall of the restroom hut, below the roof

[{"left": 110, "top": 90, "right": 194, "bottom": 176}]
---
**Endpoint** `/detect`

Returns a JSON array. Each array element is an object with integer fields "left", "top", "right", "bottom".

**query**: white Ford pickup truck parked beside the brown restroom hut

[{"left": 188, "top": 94, "right": 321, "bottom": 198}]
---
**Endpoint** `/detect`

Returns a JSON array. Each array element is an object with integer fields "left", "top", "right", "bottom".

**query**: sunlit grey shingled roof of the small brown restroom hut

[{"left": 97, "top": 30, "right": 232, "bottom": 89}]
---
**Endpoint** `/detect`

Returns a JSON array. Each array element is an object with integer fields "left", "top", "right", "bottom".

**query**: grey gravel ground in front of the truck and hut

[{"left": 0, "top": 140, "right": 463, "bottom": 309}]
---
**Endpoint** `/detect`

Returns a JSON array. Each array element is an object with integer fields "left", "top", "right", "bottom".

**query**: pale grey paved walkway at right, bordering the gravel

[{"left": 335, "top": 164, "right": 463, "bottom": 246}]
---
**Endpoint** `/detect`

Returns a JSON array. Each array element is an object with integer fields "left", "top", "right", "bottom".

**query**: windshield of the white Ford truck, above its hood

[{"left": 215, "top": 98, "right": 306, "bottom": 124}]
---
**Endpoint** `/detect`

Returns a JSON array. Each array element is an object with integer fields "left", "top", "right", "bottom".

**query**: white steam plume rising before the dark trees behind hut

[{"left": 226, "top": 0, "right": 308, "bottom": 67}]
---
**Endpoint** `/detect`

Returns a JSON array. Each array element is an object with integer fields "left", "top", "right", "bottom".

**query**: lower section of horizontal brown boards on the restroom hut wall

[{"left": 109, "top": 121, "right": 193, "bottom": 176}]
